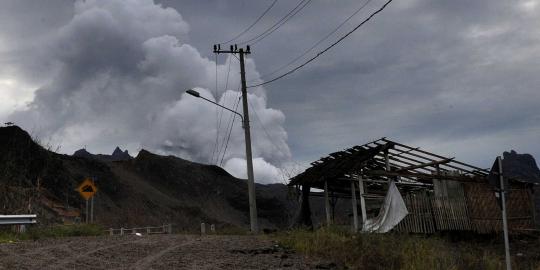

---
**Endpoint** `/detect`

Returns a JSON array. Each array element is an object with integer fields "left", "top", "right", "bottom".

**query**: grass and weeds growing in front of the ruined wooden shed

[{"left": 272, "top": 227, "right": 540, "bottom": 270}]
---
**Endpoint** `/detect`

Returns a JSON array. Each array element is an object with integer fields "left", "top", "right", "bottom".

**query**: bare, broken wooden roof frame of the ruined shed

[{"left": 289, "top": 137, "right": 489, "bottom": 192}]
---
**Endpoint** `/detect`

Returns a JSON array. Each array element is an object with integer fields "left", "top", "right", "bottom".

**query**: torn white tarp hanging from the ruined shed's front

[{"left": 362, "top": 181, "right": 409, "bottom": 233}]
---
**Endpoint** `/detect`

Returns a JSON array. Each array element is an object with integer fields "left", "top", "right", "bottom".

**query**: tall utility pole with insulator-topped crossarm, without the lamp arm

[{"left": 214, "top": 44, "right": 259, "bottom": 233}]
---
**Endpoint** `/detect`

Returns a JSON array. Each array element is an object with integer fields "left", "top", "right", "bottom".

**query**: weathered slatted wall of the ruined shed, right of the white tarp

[{"left": 386, "top": 183, "right": 535, "bottom": 234}]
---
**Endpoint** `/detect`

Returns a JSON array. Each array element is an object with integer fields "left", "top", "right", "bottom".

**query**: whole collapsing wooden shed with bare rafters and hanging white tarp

[{"left": 289, "top": 138, "right": 539, "bottom": 233}]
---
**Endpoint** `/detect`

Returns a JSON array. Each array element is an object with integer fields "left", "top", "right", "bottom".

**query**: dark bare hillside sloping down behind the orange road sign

[{"left": 0, "top": 126, "right": 296, "bottom": 230}]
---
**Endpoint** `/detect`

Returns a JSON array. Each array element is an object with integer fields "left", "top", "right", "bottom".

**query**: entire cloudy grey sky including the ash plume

[{"left": 0, "top": 0, "right": 540, "bottom": 183}]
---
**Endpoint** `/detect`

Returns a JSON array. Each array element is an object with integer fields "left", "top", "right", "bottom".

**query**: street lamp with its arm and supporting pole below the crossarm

[{"left": 186, "top": 88, "right": 259, "bottom": 233}]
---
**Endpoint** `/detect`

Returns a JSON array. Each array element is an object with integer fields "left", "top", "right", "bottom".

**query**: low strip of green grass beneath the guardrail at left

[{"left": 0, "top": 224, "right": 105, "bottom": 243}]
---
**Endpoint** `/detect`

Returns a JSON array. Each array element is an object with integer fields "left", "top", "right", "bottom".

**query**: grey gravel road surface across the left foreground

[{"left": 0, "top": 235, "right": 314, "bottom": 270}]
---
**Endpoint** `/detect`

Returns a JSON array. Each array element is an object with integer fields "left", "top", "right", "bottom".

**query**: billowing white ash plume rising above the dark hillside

[{"left": 9, "top": 0, "right": 291, "bottom": 182}]
